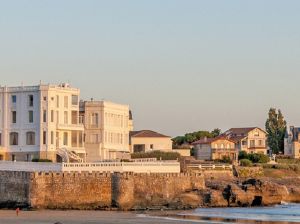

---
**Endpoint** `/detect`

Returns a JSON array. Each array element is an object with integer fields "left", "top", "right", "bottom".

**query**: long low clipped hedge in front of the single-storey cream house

[{"left": 131, "top": 151, "right": 180, "bottom": 160}]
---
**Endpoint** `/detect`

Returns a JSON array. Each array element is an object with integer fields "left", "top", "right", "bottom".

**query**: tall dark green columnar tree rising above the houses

[{"left": 266, "top": 108, "right": 286, "bottom": 154}]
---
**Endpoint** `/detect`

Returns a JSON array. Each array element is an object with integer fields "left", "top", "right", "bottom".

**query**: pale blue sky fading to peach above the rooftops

[{"left": 0, "top": 0, "right": 300, "bottom": 136}]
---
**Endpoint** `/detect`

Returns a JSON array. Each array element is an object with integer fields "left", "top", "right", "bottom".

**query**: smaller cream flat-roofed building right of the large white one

[{"left": 81, "top": 100, "right": 133, "bottom": 162}]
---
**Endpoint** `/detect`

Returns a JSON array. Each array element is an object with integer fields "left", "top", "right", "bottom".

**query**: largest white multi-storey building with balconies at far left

[{"left": 0, "top": 84, "right": 85, "bottom": 161}]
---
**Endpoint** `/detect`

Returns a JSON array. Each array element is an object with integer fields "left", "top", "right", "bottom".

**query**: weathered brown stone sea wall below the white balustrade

[{"left": 0, "top": 171, "right": 205, "bottom": 210}]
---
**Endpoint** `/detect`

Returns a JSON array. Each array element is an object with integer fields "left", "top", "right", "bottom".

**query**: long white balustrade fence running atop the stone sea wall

[{"left": 0, "top": 161, "right": 180, "bottom": 173}]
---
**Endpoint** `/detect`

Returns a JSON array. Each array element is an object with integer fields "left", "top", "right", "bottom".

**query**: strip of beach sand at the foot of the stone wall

[{"left": 0, "top": 210, "right": 195, "bottom": 224}]
